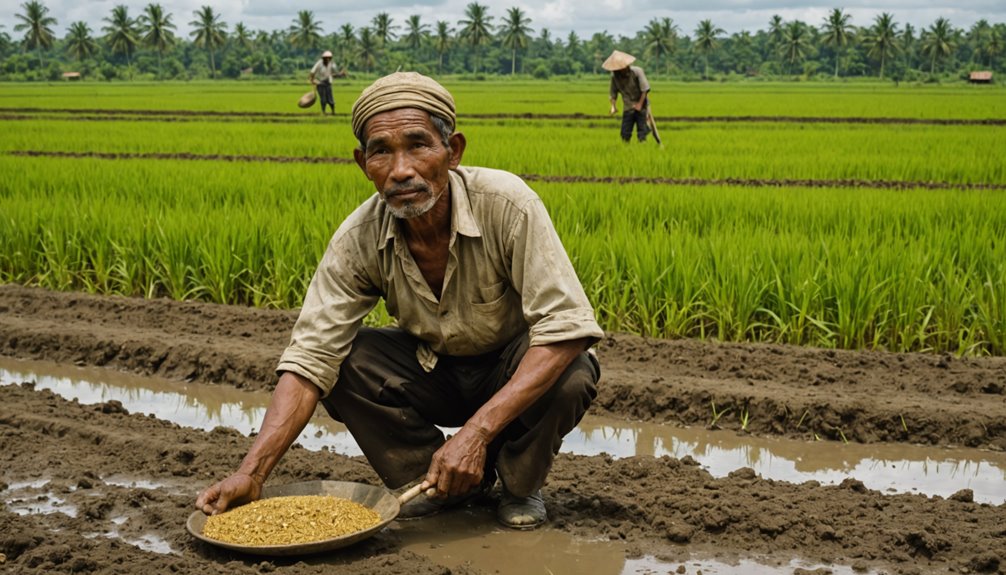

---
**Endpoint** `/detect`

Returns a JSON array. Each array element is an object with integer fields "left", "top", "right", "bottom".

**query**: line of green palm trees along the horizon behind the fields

[{"left": 0, "top": 0, "right": 1006, "bottom": 81}]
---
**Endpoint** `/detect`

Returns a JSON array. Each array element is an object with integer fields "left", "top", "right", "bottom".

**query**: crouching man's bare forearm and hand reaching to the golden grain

[{"left": 195, "top": 372, "right": 321, "bottom": 515}]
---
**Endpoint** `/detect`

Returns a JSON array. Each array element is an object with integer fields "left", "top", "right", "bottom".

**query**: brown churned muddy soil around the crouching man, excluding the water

[{"left": 0, "top": 285, "right": 1006, "bottom": 575}]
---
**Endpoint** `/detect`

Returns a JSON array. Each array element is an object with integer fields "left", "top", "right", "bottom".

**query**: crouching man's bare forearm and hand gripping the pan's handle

[{"left": 423, "top": 338, "right": 591, "bottom": 496}]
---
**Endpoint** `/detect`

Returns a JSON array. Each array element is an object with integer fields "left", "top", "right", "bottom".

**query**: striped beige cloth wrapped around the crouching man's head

[{"left": 353, "top": 72, "right": 458, "bottom": 139}]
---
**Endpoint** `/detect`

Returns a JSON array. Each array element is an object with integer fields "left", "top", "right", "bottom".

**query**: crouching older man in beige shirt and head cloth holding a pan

[{"left": 196, "top": 72, "right": 604, "bottom": 529}]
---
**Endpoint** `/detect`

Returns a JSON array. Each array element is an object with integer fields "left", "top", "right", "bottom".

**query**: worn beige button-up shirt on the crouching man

[{"left": 277, "top": 167, "right": 604, "bottom": 395}]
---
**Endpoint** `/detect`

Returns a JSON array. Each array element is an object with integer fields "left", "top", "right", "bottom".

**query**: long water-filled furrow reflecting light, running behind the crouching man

[{"left": 0, "top": 357, "right": 1006, "bottom": 505}]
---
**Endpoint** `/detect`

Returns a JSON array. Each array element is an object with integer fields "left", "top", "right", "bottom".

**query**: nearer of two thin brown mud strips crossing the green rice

[{"left": 8, "top": 150, "right": 1006, "bottom": 190}]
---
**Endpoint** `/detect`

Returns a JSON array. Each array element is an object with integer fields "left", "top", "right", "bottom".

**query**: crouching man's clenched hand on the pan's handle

[{"left": 423, "top": 425, "right": 489, "bottom": 498}]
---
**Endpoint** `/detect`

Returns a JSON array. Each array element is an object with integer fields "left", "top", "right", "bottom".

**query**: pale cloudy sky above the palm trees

[{"left": 0, "top": 0, "right": 1006, "bottom": 39}]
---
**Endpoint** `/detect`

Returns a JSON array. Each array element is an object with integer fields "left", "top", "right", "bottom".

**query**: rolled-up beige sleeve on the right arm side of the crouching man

[{"left": 508, "top": 198, "right": 605, "bottom": 346}]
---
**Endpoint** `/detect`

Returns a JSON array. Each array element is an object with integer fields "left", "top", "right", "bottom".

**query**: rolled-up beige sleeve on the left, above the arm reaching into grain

[{"left": 276, "top": 229, "right": 379, "bottom": 395}]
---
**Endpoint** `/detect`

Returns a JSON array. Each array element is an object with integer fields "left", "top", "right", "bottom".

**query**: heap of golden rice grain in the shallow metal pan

[{"left": 202, "top": 496, "right": 380, "bottom": 547}]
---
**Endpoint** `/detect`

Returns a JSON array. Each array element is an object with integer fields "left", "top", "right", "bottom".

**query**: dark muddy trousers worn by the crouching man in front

[{"left": 322, "top": 328, "right": 601, "bottom": 497}]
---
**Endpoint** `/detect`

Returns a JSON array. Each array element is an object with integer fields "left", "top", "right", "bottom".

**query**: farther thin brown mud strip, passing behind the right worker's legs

[{"left": 0, "top": 107, "right": 1006, "bottom": 126}]
